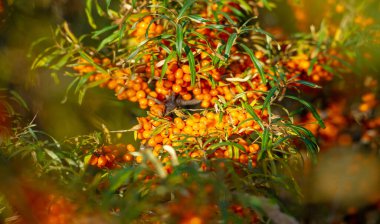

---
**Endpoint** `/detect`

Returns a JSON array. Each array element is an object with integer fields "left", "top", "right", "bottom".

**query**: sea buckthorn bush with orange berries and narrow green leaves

[{"left": 0, "top": 0, "right": 380, "bottom": 224}]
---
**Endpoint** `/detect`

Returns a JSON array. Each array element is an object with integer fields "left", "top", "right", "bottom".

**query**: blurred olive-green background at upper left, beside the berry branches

[{"left": 0, "top": 0, "right": 144, "bottom": 142}]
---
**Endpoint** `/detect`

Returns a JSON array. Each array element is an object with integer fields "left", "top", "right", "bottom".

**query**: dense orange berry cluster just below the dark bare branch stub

[{"left": 137, "top": 110, "right": 268, "bottom": 166}]
